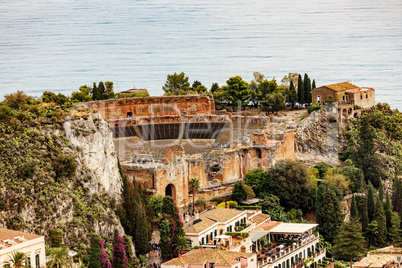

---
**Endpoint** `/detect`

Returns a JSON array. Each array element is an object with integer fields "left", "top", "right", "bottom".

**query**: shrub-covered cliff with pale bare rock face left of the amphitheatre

[{"left": 0, "top": 107, "right": 124, "bottom": 252}]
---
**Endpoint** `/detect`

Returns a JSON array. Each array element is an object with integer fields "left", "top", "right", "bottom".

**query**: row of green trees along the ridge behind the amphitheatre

[{"left": 162, "top": 72, "right": 315, "bottom": 112}]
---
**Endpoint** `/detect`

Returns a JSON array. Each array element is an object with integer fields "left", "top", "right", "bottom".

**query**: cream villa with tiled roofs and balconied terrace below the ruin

[{"left": 185, "top": 208, "right": 326, "bottom": 268}]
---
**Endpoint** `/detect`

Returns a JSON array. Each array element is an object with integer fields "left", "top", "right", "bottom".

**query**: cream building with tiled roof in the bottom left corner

[{"left": 0, "top": 228, "right": 46, "bottom": 268}]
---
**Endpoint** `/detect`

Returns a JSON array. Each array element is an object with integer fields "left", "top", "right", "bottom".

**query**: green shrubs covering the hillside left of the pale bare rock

[{"left": 0, "top": 92, "right": 124, "bottom": 258}]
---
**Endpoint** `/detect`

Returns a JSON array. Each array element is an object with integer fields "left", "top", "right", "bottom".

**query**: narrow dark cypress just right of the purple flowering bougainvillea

[{"left": 134, "top": 205, "right": 151, "bottom": 255}]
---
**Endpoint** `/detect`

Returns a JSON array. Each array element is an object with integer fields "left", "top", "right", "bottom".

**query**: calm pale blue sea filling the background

[{"left": 0, "top": 0, "right": 402, "bottom": 110}]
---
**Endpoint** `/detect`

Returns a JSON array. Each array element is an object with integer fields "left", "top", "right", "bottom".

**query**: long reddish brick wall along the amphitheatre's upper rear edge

[{"left": 85, "top": 95, "right": 215, "bottom": 120}]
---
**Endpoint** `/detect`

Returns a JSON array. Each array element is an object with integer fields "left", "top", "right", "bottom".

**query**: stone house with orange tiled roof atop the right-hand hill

[{"left": 312, "top": 82, "right": 375, "bottom": 108}]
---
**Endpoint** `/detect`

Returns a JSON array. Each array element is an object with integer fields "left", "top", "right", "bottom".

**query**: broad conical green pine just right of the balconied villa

[{"left": 332, "top": 220, "right": 366, "bottom": 262}]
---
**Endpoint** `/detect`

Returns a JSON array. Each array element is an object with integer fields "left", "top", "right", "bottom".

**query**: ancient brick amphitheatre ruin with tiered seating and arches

[{"left": 86, "top": 95, "right": 296, "bottom": 212}]
